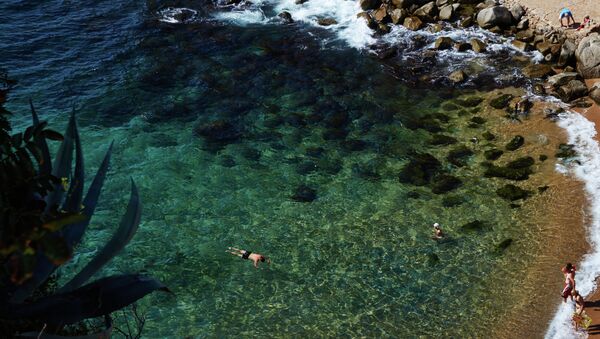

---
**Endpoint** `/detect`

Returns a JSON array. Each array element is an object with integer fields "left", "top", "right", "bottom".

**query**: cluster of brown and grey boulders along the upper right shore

[{"left": 358, "top": 0, "right": 600, "bottom": 103}]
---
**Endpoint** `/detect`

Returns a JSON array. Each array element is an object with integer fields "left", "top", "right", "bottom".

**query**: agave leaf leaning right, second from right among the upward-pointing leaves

[{"left": 63, "top": 143, "right": 113, "bottom": 247}]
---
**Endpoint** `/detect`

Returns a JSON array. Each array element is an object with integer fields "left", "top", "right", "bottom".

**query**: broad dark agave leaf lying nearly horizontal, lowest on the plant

[{"left": 5, "top": 274, "right": 170, "bottom": 325}]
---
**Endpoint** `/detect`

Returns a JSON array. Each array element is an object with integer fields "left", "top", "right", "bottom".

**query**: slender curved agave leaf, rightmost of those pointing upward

[{"left": 59, "top": 180, "right": 142, "bottom": 292}]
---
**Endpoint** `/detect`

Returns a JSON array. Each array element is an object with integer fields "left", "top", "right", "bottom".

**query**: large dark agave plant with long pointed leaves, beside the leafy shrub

[{"left": 0, "top": 102, "right": 168, "bottom": 338}]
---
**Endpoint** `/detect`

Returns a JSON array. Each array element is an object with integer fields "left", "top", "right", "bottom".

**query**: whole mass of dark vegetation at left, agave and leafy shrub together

[{"left": 0, "top": 71, "right": 167, "bottom": 335}]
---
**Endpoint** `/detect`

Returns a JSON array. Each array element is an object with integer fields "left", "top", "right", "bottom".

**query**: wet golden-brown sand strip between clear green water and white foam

[{"left": 472, "top": 89, "right": 588, "bottom": 338}]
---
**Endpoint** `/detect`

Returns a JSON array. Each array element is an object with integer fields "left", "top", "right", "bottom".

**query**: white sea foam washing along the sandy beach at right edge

[{"left": 546, "top": 112, "right": 600, "bottom": 339}]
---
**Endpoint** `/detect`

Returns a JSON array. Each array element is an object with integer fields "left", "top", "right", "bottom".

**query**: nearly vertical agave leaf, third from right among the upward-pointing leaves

[{"left": 46, "top": 114, "right": 77, "bottom": 213}]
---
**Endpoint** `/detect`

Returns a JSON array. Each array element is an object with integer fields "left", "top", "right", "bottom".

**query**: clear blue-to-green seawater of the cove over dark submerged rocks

[{"left": 0, "top": 1, "right": 552, "bottom": 338}]
